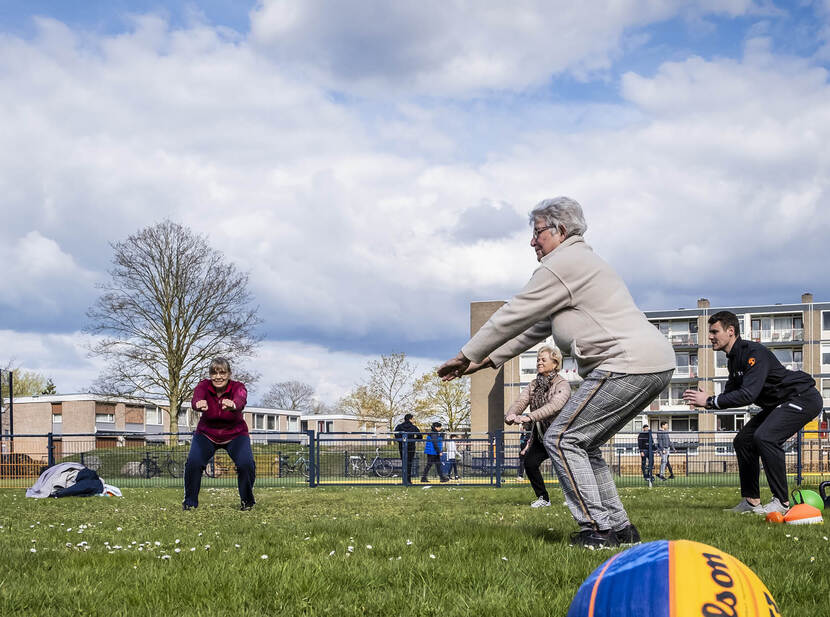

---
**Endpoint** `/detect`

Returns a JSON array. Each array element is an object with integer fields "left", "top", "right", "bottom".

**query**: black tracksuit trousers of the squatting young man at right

[{"left": 732, "top": 388, "right": 823, "bottom": 503}]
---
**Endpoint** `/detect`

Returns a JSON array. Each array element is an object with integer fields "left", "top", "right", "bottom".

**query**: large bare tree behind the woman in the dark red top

[{"left": 87, "top": 221, "right": 260, "bottom": 434}]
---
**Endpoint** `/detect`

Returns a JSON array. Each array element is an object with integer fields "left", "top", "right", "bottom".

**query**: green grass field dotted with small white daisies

[{"left": 0, "top": 485, "right": 830, "bottom": 617}]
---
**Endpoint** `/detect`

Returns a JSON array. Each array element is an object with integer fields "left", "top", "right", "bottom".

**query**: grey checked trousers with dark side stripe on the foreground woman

[{"left": 545, "top": 370, "right": 673, "bottom": 531}]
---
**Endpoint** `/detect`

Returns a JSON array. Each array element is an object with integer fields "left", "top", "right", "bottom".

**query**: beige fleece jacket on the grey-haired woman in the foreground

[{"left": 461, "top": 236, "right": 675, "bottom": 377}]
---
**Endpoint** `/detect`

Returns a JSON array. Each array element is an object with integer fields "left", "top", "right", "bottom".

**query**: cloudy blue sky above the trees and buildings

[{"left": 0, "top": 0, "right": 830, "bottom": 403}]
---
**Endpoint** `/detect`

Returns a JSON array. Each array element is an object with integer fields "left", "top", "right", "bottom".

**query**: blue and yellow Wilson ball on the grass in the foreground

[{"left": 568, "top": 540, "right": 780, "bottom": 617}]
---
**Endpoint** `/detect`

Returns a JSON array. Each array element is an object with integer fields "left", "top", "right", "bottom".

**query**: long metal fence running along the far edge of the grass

[{"left": 0, "top": 431, "right": 830, "bottom": 488}]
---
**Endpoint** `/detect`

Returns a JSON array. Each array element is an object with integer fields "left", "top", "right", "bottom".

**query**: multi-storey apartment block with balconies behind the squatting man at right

[{"left": 470, "top": 293, "right": 830, "bottom": 433}]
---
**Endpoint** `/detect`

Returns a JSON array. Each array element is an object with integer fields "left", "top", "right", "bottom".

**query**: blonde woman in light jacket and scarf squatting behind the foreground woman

[{"left": 504, "top": 345, "right": 571, "bottom": 508}]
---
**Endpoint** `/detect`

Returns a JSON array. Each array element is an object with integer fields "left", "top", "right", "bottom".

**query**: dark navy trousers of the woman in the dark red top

[{"left": 184, "top": 433, "right": 256, "bottom": 507}]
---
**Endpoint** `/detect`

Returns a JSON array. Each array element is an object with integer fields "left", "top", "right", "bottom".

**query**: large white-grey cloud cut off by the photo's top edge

[{"left": 251, "top": 0, "right": 758, "bottom": 96}]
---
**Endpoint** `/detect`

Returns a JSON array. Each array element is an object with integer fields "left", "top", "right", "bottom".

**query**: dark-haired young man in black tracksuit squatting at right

[{"left": 683, "top": 311, "right": 822, "bottom": 514}]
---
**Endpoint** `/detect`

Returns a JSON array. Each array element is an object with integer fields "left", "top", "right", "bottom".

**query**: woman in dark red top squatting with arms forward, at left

[{"left": 182, "top": 358, "right": 256, "bottom": 510}]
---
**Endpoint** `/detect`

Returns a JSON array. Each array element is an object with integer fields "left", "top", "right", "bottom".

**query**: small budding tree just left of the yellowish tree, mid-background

[{"left": 340, "top": 353, "right": 415, "bottom": 432}]
